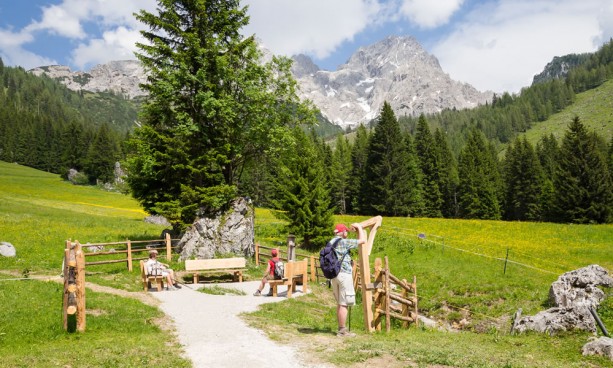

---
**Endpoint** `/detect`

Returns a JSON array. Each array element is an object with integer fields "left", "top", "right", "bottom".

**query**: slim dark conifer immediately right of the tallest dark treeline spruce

[{"left": 415, "top": 114, "right": 443, "bottom": 217}]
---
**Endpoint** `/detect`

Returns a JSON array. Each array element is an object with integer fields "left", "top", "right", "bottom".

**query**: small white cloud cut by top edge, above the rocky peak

[{"left": 400, "top": 0, "right": 464, "bottom": 28}]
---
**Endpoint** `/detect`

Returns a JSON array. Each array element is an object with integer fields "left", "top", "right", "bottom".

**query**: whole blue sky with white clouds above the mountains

[{"left": 0, "top": 0, "right": 613, "bottom": 93}]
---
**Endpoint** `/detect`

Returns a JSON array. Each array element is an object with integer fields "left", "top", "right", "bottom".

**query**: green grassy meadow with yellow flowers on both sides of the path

[{"left": 0, "top": 162, "right": 613, "bottom": 367}]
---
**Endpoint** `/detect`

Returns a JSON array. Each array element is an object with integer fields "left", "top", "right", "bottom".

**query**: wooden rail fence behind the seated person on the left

[{"left": 76, "top": 234, "right": 178, "bottom": 272}]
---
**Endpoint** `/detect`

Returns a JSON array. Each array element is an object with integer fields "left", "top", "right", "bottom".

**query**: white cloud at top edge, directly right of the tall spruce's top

[{"left": 241, "top": 0, "right": 386, "bottom": 59}]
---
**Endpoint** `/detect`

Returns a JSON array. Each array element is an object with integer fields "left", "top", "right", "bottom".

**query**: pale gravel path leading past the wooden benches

[{"left": 150, "top": 281, "right": 324, "bottom": 368}]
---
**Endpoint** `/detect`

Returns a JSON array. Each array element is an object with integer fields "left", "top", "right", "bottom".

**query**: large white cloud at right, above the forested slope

[{"left": 432, "top": 0, "right": 608, "bottom": 92}]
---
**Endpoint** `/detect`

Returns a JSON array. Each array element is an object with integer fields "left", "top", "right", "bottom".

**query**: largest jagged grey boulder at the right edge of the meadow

[{"left": 511, "top": 265, "right": 613, "bottom": 335}]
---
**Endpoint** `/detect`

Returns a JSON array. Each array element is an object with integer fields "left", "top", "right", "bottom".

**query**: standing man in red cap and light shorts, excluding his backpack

[{"left": 331, "top": 223, "right": 366, "bottom": 337}]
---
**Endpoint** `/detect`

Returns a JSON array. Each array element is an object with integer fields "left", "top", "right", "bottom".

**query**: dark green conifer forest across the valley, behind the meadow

[{"left": 0, "top": 38, "right": 613, "bottom": 226}]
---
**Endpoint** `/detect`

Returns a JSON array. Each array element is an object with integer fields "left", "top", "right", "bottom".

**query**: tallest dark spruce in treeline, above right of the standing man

[{"left": 365, "top": 102, "right": 410, "bottom": 216}]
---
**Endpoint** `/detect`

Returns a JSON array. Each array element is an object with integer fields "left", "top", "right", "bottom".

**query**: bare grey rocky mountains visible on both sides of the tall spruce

[{"left": 30, "top": 36, "right": 493, "bottom": 129}]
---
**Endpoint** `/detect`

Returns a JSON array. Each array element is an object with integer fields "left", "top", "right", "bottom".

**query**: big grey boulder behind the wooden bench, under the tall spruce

[{"left": 178, "top": 198, "right": 255, "bottom": 261}]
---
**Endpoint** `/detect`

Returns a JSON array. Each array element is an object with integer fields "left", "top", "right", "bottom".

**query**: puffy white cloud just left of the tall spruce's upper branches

[{"left": 72, "top": 27, "right": 142, "bottom": 69}]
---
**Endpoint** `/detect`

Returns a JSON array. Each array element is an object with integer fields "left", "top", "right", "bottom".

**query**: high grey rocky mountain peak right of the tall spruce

[{"left": 296, "top": 36, "right": 493, "bottom": 127}]
